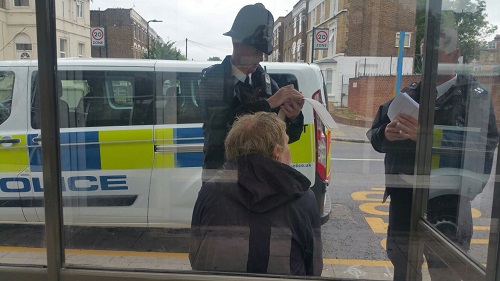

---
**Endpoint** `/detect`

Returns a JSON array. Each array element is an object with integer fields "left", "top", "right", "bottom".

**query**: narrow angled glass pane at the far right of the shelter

[{"left": 427, "top": 5, "right": 498, "bottom": 272}]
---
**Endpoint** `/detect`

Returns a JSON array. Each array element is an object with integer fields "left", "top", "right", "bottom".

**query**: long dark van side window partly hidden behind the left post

[{"left": 31, "top": 71, "right": 154, "bottom": 129}]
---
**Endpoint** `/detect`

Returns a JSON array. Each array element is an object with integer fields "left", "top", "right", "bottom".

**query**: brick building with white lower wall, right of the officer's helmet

[{"left": 270, "top": 0, "right": 416, "bottom": 106}]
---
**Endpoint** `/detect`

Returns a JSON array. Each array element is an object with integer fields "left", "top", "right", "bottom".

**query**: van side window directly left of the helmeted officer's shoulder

[{"left": 156, "top": 73, "right": 202, "bottom": 124}]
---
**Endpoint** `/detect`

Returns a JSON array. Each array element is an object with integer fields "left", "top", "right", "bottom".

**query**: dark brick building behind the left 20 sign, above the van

[{"left": 90, "top": 8, "right": 163, "bottom": 59}]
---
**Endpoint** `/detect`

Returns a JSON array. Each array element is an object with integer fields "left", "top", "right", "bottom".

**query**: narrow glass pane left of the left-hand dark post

[{"left": 0, "top": 0, "right": 47, "bottom": 266}]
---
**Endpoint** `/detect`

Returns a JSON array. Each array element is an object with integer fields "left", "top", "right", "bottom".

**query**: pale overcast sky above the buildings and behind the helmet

[{"left": 90, "top": 0, "right": 500, "bottom": 61}]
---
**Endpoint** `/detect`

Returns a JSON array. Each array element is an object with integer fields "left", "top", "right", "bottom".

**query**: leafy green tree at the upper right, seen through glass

[{"left": 415, "top": 0, "right": 497, "bottom": 63}]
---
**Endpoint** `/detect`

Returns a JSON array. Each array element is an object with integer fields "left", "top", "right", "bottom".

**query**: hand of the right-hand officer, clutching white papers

[{"left": 384, "top": 113, "right": 418, "bottom": 141}]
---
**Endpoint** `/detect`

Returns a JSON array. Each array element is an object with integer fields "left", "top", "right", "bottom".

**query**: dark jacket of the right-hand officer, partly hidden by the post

[{"left": 367, "top": 75, "right": 498, "bottom": 199}]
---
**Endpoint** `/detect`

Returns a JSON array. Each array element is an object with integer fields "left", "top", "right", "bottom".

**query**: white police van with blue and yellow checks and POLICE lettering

[{"left": 0, "top": 59, "right": 330, "bottom": 227}]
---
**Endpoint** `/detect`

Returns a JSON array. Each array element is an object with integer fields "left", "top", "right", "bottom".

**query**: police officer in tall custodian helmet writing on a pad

[{"left": 197, "top": 3, "right": 304, "bottom": 181}]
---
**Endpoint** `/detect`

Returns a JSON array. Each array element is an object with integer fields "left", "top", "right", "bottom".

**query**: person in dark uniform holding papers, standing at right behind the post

[{"left": 367, "top": 28, "right": 498, "bottom": 281}]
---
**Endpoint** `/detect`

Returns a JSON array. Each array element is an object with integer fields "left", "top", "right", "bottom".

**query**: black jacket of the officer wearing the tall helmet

[{"left": 197, "top": 56, "right": 304, "bottom": 169}]
